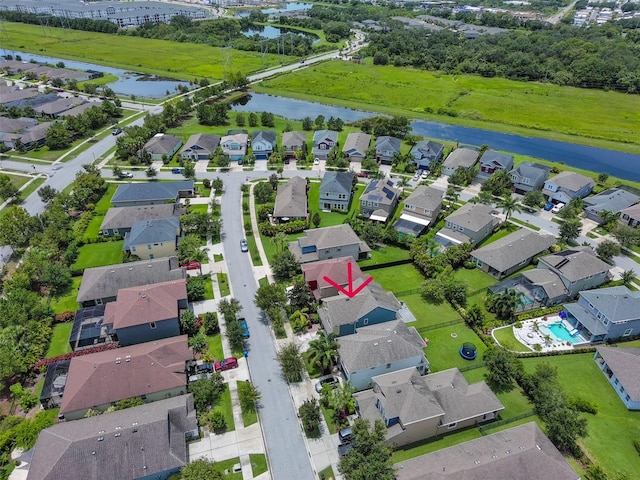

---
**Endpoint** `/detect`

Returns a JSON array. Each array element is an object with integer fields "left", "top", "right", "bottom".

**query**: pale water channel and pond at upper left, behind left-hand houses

[{"left": 0, "top": 49, "right": 188, "bottom": 98}]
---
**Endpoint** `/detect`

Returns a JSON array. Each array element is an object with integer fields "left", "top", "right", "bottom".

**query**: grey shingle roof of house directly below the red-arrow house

[{"left": 338, "top": 320, "right": 425, "bottom": 372}]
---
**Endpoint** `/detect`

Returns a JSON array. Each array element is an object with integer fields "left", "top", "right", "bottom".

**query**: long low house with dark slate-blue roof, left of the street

[{"left": 111, "top": 180, "right": 195, "bottom": 207}]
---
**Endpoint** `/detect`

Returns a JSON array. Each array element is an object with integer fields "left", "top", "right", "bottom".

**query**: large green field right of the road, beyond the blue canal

[{"left": 253, "top": 61, "right": 640, "bottom": 153}]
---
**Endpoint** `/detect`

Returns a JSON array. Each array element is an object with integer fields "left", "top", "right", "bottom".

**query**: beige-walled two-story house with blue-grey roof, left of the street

[{"left": 122, "top": 217, "right": 182, "bottom": 260}]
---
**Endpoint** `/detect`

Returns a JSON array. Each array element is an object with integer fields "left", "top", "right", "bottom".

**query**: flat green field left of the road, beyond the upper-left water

[{"left": 2, "top": 22, "right": 294, "bottom": 80}]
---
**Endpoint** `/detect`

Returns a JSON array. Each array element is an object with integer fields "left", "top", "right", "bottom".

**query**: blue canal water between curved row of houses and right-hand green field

[{"left": 233, "top": 94, "right": 640, "bottom": 181}]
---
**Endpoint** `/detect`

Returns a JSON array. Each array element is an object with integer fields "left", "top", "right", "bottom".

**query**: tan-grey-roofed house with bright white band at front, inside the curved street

[{"left": 393, "top": 185, "right": 444, "bottom": 237}]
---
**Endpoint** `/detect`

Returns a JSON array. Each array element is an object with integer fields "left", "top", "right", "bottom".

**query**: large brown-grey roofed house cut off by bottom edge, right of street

[{"left": 394, "top": 422, "right": 581, "bottom": 480}]
